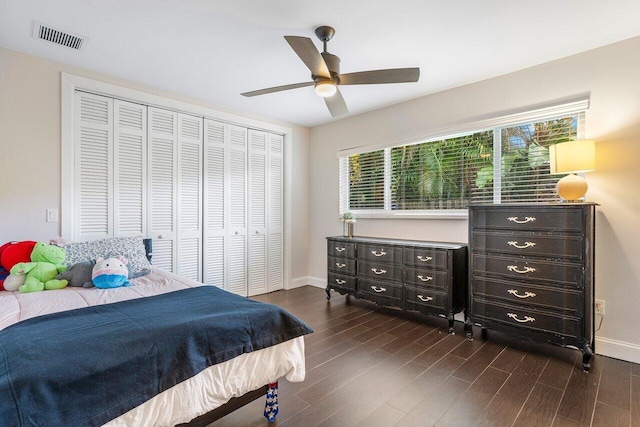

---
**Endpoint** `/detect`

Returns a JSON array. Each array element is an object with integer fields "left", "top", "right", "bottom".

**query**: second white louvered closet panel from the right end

[{"left": 248, "top": 129, "right": 268, "bottom": 296}]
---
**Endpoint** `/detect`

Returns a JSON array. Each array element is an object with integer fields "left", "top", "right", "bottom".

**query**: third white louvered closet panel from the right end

[{"left": 226, "top": 125, "right": 247, "bottom": 296}]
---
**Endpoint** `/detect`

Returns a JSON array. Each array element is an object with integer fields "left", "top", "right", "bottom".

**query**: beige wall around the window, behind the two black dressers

[{"left": 309, "top": 38, "right": 640, "bottom": 362}]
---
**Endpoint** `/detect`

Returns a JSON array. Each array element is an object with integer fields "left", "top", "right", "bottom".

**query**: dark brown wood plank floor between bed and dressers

[{"left": 212, "top": 286, "right": 640, "bottom": 427}]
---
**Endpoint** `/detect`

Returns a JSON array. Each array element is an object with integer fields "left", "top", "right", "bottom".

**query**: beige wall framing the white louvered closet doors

[{"left": 0, "top": 48, "right": 309, "bottom": 279}]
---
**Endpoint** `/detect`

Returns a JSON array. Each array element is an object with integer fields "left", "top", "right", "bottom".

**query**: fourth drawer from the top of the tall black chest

[{"left": 471, "top": 277, "right": 584, "bottom": 315}]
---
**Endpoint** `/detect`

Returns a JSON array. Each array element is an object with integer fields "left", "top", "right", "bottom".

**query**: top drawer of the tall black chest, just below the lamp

[{"left": 471, "top": 206, "right": 584, "bottom": 232}]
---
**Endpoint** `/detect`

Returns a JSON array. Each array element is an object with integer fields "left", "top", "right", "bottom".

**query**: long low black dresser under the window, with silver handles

[{"left": 326, "top": 236, "right": 468, "bottom": 332}]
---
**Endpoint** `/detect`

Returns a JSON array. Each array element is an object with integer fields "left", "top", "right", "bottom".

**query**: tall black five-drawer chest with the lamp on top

[{"left": 467, "top": 203, "right": 595, "bottom": 371}]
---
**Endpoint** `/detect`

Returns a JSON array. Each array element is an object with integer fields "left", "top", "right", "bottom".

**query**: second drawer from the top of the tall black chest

[{"left": 472, "top": 230, "right": 584, "bottom": 260}]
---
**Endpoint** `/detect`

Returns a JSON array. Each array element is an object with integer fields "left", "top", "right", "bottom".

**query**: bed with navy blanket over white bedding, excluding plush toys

[{"left": 0, "top": 246, "right": 312, "bottom": 426}]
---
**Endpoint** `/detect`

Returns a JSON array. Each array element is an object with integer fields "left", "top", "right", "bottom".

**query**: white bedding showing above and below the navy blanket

[{"left": 0, "top": 268, "right": 305, "bottom": 427}]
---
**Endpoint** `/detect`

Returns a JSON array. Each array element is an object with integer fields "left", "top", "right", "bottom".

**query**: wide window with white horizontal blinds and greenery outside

[{"left": 340, "top": 110, "right": 584, "bottom": 216}]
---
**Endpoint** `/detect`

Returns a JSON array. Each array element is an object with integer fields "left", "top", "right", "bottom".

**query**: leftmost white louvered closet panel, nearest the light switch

[{"left": 74, "top": 92, "right": 113, "bottom": 241}]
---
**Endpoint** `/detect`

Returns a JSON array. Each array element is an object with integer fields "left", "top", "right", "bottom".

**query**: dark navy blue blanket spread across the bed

[{"left": 0, "top": 286, "right": 313, "bottom": 426}]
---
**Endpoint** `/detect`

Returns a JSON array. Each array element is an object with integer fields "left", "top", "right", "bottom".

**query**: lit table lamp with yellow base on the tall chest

[{"left": 549, "top": 139, "right": 596, "bottom": 202}]
